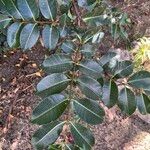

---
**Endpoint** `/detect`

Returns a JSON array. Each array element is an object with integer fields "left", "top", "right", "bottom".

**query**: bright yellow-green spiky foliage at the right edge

[{"left": 133, "top": 37, "right": 150, "bottom": 71}]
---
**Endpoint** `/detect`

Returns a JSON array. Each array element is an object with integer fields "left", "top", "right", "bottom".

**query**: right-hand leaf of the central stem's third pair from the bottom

[{"left": 77, "top": 76, "right": 102, "bottom": 100}]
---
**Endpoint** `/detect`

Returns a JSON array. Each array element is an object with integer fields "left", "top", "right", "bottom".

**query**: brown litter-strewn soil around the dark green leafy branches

[{"left": 0, "top": 0, "right": 150, "bottom": 150}]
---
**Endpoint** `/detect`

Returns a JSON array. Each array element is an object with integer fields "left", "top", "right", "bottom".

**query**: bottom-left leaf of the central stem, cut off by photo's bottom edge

[{"left": 32, "top": 122, "right": 65, "bottom": 150}]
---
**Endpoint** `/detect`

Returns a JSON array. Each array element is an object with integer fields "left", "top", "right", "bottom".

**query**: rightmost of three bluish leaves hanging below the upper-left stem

[{"left": 42, "top": 25, "right": 59, "bottom": 50}]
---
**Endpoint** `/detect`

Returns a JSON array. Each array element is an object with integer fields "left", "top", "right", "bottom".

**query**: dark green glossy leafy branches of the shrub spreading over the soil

[{"left": 0, "top": 0, "right": 150, "bottom": 150}]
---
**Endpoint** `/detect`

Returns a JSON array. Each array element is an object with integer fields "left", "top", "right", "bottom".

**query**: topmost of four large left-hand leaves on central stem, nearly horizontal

[{"left": 43, "top": 54, "right": 73, "bottom": 73}]
